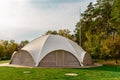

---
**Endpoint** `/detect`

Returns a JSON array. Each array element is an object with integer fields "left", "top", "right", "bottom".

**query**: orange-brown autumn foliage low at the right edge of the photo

[{"left": 101, "top": 36, "right": 120, "bottom": 63}]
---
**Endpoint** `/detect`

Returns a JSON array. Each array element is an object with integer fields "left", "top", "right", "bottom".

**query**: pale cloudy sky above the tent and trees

[{"left": 0, "top": 0, "right": 96, "bottom": 42}]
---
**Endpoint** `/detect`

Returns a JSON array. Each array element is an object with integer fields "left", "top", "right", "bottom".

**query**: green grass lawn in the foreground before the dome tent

[{"left": 0, "top": 66, "right": 120, "bottom": 80}]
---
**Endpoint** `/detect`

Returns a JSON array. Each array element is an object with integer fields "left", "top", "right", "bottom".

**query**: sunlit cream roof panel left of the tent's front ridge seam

[{"left": 22, "top": 35, "right": 49, "bottom": 63}]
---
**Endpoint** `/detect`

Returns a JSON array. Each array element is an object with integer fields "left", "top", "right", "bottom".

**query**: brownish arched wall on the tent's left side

[{"left": 10, "top": 50, "right": 35, "bottom": 66}]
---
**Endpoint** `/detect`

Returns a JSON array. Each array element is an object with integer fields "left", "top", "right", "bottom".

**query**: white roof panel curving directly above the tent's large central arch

[{"left": 38, "top": 35, "right": 82, "bottom": 64}]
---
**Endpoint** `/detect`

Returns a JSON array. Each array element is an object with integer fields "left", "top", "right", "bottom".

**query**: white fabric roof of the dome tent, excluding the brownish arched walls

[{"left": 22, "top": 35, "right": 86, "bottom": 66}]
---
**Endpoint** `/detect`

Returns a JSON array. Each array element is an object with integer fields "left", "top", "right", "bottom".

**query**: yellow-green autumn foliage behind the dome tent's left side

[{"left": 0, "top": 40, "right": 28, "bottom": 60}]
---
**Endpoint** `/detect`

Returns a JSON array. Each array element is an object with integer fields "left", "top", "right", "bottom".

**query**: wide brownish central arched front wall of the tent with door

[{"left": 38, "top": 50, "right": 80, "bottom": 67}]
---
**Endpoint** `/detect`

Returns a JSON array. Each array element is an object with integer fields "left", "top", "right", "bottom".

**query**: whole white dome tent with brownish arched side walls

[{"left": 10, "top": 35, "right": 92, "bottom": 67}]
